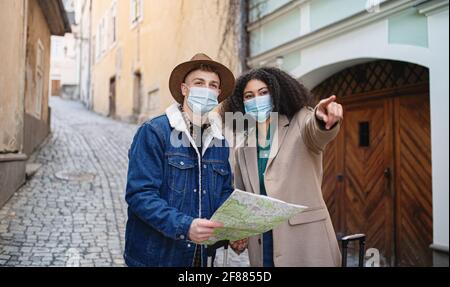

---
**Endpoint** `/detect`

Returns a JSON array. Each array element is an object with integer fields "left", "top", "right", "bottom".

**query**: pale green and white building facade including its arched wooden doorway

[{"left": 247, "top": 0, "right": 449, "bottom": 266}]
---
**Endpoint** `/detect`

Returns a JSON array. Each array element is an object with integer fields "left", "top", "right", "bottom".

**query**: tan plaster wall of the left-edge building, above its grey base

[{"left": 0, "top": 0, "right": 55, "bottom": 153}]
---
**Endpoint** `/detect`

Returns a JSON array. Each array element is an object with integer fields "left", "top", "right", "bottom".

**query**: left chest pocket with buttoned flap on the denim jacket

[{"left": 168, "top": 156, "right": 195, "bottom": 193}]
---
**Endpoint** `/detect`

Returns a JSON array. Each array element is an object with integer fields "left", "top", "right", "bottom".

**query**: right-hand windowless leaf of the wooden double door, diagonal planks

[{"left": 395, "top": 93, "right": 433, "bottom": 266}]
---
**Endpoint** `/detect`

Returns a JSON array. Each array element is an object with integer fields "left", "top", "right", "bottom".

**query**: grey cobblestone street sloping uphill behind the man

[{"left": 0, "top": 98, "right": 248, "bottom": 266}]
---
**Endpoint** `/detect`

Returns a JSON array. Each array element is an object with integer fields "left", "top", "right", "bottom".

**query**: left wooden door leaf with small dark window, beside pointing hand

[{"left": 341, "top": 95, "right": 394, "bottom": 266}]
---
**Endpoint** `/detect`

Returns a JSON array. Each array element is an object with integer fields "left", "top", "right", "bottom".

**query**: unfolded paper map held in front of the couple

[{"left": 204, "top": 190, "right": 307, "bottom": 245}]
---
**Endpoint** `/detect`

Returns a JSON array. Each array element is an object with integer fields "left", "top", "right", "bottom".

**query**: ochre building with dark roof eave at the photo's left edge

[{"left": 0, "top": 0, "right": 70, "bottom": 206}]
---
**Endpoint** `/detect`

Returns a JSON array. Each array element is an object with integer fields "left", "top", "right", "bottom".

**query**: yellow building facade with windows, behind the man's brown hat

[{"left": 81, "top": 0, "right": 240, "bottom": 122}]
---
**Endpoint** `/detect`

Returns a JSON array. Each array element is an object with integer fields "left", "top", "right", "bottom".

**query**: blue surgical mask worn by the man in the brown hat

[{"left": 187, "top": 87, "right": 219, "bottom": 116}]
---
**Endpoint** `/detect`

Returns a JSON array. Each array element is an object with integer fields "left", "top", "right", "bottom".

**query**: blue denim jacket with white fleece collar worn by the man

[{"left": 124, "top": 104, "right": 232, "bottom": 267}]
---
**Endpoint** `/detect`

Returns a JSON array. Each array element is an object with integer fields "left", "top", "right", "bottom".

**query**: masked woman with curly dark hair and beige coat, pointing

[{"left": 225, "top": 68, "right": 343, "bottom": 267}]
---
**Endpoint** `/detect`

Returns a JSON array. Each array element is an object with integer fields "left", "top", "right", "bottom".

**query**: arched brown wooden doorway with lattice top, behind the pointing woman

[{"left": 313, "top": 60, "right": 433, "bottom": 266}]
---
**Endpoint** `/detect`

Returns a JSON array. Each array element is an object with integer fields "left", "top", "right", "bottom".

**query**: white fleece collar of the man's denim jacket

[{"left": 166, "top": 103, "right": 224, "bottom": 140}]
